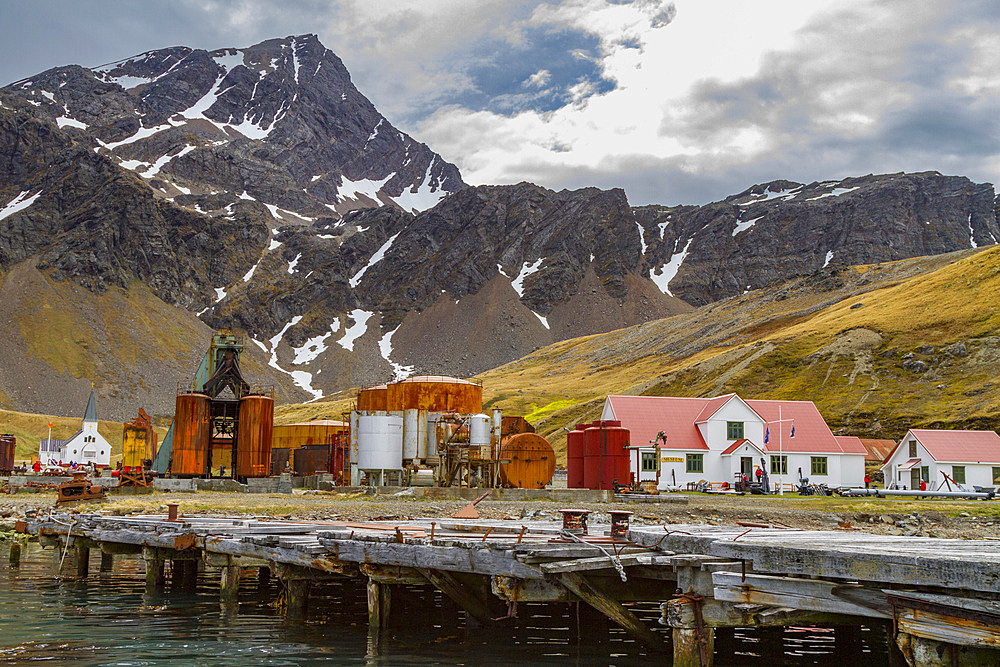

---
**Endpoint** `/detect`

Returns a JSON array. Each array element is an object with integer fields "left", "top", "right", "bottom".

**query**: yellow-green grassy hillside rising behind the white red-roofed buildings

[{"left": 472, "top": 247, "right": 1000, "bottom": 460}]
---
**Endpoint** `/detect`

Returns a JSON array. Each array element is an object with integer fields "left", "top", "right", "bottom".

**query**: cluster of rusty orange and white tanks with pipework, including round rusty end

[{"left": 350, "top": 376, "right": 555, "bottom": 488}]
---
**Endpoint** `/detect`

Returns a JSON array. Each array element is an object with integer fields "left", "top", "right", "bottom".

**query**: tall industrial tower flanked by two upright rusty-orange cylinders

[{"left": 153, "top": 329, "right": 274, "bottom": 480}]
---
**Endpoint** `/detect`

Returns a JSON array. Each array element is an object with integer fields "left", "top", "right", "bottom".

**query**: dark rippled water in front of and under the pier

[{"left": 0, "top": 543, "right": 885, "bottom": 667}]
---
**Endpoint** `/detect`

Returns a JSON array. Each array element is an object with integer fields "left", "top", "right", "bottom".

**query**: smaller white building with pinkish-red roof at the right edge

[{"left": 882, "top": 428, "right": 1000, "bottom": 491}]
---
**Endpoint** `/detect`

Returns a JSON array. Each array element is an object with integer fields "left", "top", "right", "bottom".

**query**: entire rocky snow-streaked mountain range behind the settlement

[{"left": 0, "top": 35, "right": 1000, "bottom": 416}]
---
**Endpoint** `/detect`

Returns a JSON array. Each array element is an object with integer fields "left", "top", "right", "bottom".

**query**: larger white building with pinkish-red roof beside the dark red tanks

[{"left": 601, "top": 394, "right": 865, "bottom": 490}]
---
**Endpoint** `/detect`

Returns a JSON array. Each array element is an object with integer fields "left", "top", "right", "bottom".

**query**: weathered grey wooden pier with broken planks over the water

[{"left": 11, "top": 513, "right": 1000, "bottom": 667}]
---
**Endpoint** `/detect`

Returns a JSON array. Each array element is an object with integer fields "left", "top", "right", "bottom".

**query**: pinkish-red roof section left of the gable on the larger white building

[{"left": 608, "top": 396, "right": 708, "bottom": 449}]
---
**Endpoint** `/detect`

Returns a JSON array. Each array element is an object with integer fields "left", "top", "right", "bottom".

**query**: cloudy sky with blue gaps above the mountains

[{"left": 0, "top": 0, "right": 1000, "bottom": 204}]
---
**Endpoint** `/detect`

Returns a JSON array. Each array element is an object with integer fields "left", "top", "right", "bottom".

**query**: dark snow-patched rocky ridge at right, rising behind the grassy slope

[{"left": 636, "top": 172, "right": 1000, "bottom": 305}]
